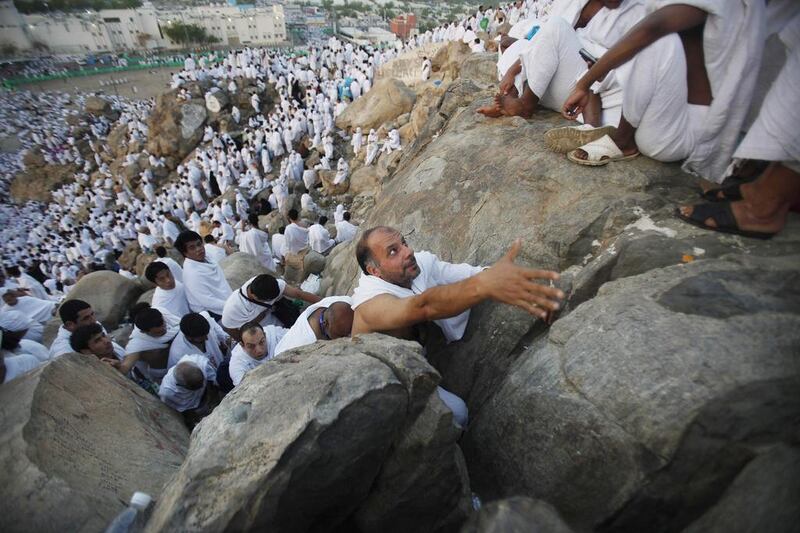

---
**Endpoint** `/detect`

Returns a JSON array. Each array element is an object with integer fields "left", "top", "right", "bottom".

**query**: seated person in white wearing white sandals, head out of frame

[{"left": 562, "top": 0, "right": 764, "bottom": 169}]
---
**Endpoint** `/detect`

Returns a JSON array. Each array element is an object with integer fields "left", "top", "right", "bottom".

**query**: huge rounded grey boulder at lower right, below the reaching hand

[{"left": 465, "top": 255, "right": 800, "bottom": 531}]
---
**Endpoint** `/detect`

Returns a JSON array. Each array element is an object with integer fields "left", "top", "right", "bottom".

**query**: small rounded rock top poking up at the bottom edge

[{"left": 461, "top": 496, "right": 572, "bottom": 533}]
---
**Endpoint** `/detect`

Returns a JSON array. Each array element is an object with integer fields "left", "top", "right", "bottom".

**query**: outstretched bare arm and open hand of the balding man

[{"left": 353, "top": 240, "right": 564, "bottom": 334}]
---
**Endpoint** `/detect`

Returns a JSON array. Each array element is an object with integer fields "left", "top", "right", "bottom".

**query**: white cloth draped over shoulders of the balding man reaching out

[{"left": 352, "top": 252, "right": 484, "bottom": 342}]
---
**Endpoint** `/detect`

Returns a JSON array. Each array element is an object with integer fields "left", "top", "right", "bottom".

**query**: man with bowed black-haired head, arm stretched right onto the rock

[{"left": 221, "top": 274, "right": 320, "bottom": 339}]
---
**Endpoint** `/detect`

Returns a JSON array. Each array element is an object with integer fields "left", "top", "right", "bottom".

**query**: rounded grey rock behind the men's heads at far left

[{"left": 67, "top": 270, "right": 142, "bottom": 329}]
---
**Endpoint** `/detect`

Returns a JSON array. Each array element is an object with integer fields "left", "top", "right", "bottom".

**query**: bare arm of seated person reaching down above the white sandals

[{"left": 561, "top": 4, "right": 708, "bottom": 120}]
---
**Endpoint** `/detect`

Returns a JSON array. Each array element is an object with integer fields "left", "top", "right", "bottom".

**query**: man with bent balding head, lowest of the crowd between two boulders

[{"left": 158, "top": 354, "right": 220, "bottom": 430}]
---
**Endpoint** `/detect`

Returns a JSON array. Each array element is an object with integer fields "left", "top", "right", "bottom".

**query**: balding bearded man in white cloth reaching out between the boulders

[{"left": 352, "top": 226, "right": 564, "bottom": 427}]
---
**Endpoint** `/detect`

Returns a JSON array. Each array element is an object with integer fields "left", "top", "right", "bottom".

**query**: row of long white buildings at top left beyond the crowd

[{"left": 0, "top": 0, "right": 286, "bottom": 54}]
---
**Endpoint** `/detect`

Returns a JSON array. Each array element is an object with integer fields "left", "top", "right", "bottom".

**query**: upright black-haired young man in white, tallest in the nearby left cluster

[{"left": 175, "top": 231, "right": 233, "bottom": 320}]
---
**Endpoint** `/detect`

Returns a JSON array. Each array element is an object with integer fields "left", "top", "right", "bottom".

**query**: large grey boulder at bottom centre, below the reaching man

[{"left": 148, "top": 335, "right": 469, "bottom": 532}]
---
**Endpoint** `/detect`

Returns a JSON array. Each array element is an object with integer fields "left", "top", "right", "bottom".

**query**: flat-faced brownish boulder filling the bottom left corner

[{"left": 0, "top": 354, "right": 189, "bottom": 533}]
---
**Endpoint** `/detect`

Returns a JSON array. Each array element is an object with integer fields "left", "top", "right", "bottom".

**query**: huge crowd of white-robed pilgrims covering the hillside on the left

[{"left": 0, "top": 0, "right": 550, "bottom": 421}]
